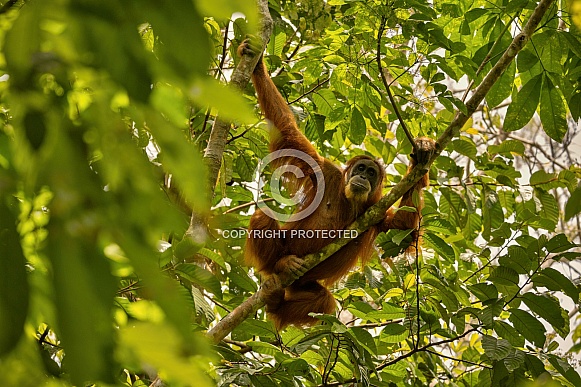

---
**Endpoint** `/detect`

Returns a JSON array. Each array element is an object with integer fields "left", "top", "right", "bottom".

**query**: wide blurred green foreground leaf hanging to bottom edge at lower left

[{"left": 48, "top": 227, "right": 116, "bottom": 384}]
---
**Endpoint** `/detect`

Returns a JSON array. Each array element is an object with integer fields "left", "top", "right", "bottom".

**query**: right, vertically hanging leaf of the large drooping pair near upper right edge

[{"left": 539, "top": 76, "right": 567, "bottom": 142}]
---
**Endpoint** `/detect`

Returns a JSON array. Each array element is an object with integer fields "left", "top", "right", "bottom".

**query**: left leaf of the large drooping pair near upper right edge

[{"left": 504, "top": 75, "right": 543, "bottom": 132}]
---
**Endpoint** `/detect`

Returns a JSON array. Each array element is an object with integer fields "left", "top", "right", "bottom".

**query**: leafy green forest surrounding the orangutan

[{"left": 0, "top": 0, "right": 581, "bottom": 386}]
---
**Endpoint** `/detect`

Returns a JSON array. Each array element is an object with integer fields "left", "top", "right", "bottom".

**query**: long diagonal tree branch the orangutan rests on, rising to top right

[{"left": 207, "top": 0, "right": 554, "bottom": 350}]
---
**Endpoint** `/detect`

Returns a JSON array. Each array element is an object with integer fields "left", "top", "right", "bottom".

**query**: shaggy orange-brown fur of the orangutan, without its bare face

[{"left": 241, "top": 46, "right": 428, "bottom": 329}]
